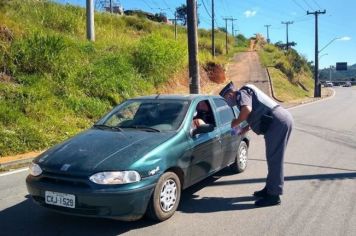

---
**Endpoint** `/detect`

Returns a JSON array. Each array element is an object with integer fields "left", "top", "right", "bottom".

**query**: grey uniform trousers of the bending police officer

[{"left": 264, "top": 106, "right": 293, "bottom": 195}]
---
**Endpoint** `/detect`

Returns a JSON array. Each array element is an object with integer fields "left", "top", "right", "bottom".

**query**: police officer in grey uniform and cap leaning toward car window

[{"left": 220, "top": 82, "right": 293, "bottom": 207}]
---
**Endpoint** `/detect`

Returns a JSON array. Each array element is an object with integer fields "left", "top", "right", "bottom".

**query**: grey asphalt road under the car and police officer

[{"left": 0, "top": 88, "right": 356, "bottom": 235}]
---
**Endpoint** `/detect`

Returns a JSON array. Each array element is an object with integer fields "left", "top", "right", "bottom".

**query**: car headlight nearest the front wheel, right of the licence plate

[{"left": 89, "top": 171, "right": 141, "bottom": 184}]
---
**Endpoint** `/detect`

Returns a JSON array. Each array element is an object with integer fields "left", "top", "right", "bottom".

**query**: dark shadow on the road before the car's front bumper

[{"left": 0, "top": 196, "right": 155, "bottom": 236}]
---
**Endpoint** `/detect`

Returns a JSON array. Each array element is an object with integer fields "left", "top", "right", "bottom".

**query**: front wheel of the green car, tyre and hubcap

[{"left": 146, "top": 172, "right": 181, "bottom": 221}]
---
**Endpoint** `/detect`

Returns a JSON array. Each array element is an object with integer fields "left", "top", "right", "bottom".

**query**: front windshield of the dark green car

[{"left": 95, "top": 99, "right": 189, "bottom": 132}]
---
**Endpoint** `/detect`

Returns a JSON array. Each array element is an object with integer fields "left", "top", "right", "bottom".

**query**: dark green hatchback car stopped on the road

[{"left": 26, "top": 95, "right": 249, "bottom": 221}]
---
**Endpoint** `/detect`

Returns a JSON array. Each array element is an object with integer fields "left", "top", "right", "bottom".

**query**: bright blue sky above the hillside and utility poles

[{"left": 56, "top": 0, "right": 356, "bottom": 69}]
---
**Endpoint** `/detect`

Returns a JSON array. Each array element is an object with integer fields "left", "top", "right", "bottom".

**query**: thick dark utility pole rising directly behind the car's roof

[{"left": 187, "top": 0, "right": 200, "bottom": 94}]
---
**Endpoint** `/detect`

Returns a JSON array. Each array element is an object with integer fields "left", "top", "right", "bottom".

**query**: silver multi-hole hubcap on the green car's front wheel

[{"left": 160, "top": 179, "right": 177, "bottom": 212}]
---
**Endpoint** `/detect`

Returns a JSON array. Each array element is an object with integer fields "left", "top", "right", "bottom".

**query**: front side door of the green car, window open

[{"left": 189, "top": 100, "right": 221, "bottom": 184}]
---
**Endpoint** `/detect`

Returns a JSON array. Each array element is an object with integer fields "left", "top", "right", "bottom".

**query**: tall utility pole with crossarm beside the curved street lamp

[{"left": 307, "top": 10, "right": 326, "bottom": 97}]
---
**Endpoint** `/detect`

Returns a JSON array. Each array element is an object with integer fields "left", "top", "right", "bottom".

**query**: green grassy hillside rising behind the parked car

[{"left": 0, "top": 0, "right": 244, "bottom": 157}]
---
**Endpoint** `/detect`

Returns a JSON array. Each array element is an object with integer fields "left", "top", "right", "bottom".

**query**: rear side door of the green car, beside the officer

[{"left": 213, "top": 98, "right": 241, "bottom": 168}]
